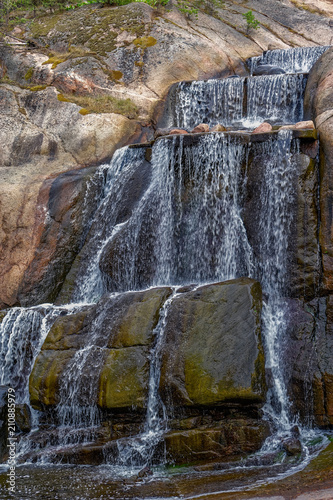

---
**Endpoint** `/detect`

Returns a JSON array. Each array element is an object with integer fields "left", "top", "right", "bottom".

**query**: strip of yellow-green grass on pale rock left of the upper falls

[{"left": 58, "top": 94, "right": 138, "bottom": 119}]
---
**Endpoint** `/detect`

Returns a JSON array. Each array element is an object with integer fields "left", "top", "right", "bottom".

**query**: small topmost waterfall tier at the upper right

[{"left": 248, "top": 45, "right": 331, "bottom": 75}]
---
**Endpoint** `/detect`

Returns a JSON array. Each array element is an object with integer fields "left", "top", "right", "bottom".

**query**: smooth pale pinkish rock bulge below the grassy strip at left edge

[{"left": 0, "top": 85, "right": 135, "bottom": 306}]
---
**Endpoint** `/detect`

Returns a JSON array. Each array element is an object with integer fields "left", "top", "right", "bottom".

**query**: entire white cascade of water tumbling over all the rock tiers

[{"left": 0, "top": 48, "right": 324, "bottom": 492}]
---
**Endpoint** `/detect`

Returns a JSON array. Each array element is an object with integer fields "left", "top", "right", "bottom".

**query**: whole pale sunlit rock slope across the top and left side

[{"left": 0, "top": 0, "right": 331, "bottom": 307}]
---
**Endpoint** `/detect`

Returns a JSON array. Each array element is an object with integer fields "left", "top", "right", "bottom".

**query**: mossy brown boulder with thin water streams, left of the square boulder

[{"left": 30, "top": 287, "right": 171, "bottom": 409}]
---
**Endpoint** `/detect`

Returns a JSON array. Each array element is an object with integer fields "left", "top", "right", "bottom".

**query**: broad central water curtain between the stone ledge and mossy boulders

[{"left": 97, "top": 133, "right": 252, "bottom": 291}]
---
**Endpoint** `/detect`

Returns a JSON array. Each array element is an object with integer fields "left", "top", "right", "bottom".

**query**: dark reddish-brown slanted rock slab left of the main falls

[{"left": 19, "top": 167, "right": 102, "bottom": 306}]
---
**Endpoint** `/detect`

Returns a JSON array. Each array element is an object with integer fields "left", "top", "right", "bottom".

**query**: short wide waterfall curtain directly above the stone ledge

[{"left": 174, "top": 74, "right": 307, "bottom": 130}]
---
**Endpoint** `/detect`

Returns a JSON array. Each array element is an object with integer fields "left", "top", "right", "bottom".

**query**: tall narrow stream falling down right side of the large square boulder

[{"left": 255, "top": 130, "right": 297, "bottom": 430}]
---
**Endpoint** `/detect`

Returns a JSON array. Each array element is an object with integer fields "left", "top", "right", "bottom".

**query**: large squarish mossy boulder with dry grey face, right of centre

[{"left": 160, "top": 278, "right": 265, "bottom": 408}]
